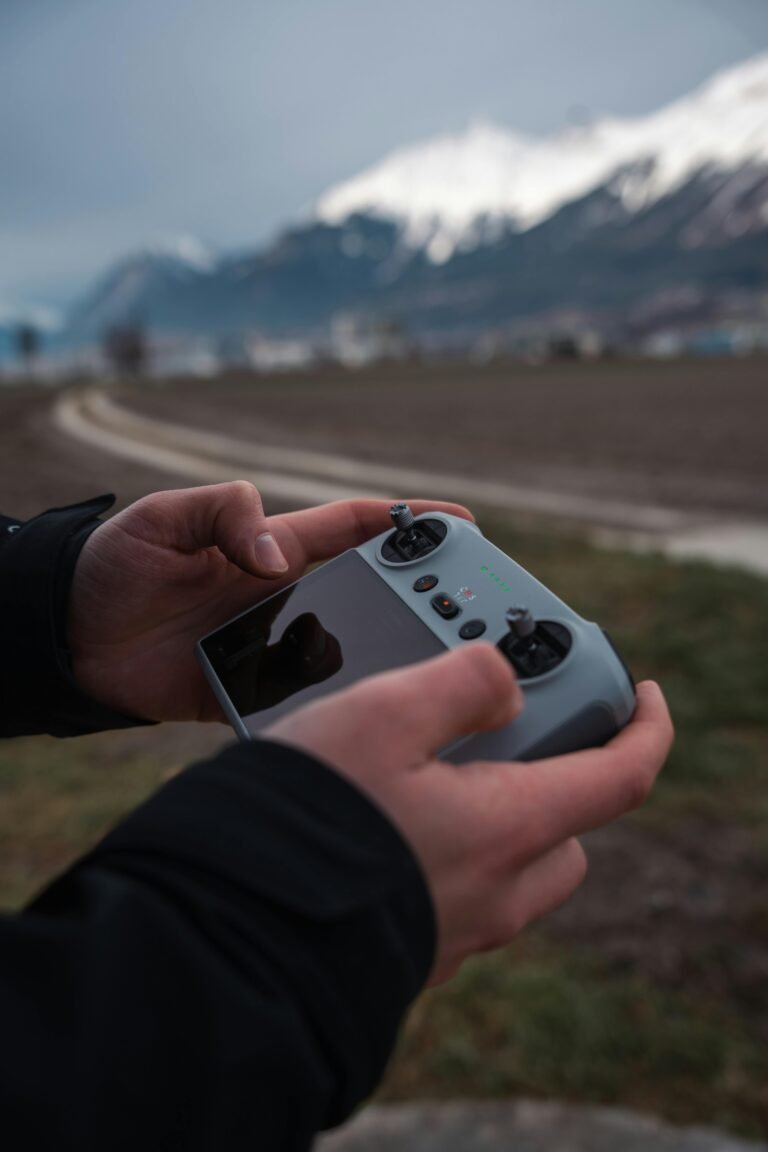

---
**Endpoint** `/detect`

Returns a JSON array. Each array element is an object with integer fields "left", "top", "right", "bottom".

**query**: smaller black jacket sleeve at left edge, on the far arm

[{"left": 0, "top": 495, "right": 151, "bottom": 736}]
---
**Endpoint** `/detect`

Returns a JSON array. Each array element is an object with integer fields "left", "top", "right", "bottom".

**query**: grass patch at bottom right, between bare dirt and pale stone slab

[{"left": 382, "top": 937, "right": 768, "bottom": 1135}]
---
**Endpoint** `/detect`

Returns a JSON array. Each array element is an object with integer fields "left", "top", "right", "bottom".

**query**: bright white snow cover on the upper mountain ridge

[{"left": 317, "top": 54, "right": 768, "bottom": 263}]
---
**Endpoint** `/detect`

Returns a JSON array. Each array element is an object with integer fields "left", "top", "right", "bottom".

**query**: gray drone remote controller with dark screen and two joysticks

[{"left": 198, "top": 505, "right": 634, "bottom": 763}]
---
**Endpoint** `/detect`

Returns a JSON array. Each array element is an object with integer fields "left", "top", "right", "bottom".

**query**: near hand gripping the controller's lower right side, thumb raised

[{"left": 264, "top": 644, "right": 672, "bottom": 983}]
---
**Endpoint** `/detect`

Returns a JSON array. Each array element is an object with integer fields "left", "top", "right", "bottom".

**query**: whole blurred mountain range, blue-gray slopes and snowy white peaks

[{"left": 55, "top": 55, "right": 768, "bottom": 346}]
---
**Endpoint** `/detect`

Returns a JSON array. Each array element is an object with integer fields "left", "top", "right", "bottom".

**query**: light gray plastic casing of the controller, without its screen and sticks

[{"left": 198, "top": 511, "right": 636, "bottom": 763}]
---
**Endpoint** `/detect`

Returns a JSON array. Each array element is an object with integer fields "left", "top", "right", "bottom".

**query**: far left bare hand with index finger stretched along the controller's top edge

[{"left": 68, "top": 480, "right": 470, "bottom": 720}]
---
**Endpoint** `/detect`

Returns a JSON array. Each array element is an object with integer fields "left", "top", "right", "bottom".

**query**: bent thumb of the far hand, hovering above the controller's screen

[{"left": 149, "top": 480, "right": 288, "bottom": 577}]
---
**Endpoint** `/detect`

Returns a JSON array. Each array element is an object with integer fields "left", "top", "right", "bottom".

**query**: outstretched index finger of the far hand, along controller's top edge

[{"left": 268, "top": 500, "right": 473, "bottom": 571}]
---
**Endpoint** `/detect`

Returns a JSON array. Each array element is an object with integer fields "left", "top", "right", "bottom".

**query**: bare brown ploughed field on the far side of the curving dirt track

[{"left": 118, "top": 358, "right": 768, "bottom": 516}]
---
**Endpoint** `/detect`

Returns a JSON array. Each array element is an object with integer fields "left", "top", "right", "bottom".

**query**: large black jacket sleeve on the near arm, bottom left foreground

[{"left": 0, "top": 742, "right": 434, "bottom": 1152}]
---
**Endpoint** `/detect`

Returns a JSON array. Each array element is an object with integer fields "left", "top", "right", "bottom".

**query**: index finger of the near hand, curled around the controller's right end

[{"left": 495, "top": 681, "right": 674, "bottom": 852}]
